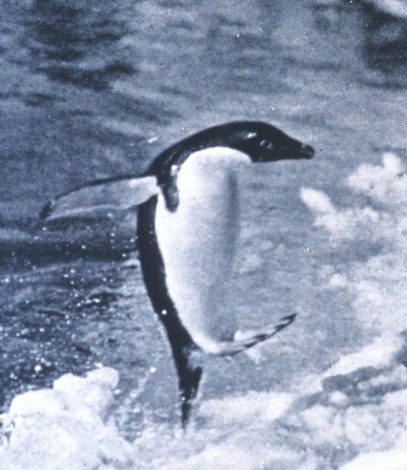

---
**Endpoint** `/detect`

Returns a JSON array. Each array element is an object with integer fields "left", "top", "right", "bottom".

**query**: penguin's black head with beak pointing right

[{"left": 228, "top": 122, "right": 315, "bottom": 162}]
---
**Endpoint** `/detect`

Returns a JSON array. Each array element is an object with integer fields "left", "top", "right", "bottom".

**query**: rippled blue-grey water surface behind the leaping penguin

[{"left": 0, "top": 0, "right": 407, "bottom": 434}]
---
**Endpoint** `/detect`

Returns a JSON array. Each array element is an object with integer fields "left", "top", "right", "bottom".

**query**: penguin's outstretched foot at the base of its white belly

[{"left": 213, "top": 313, "right": 297, "bottom": 356}]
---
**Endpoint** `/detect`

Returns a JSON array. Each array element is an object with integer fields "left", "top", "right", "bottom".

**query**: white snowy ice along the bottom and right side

[{"left": 0, "top": 153, "right": 407, "bottom": 470}]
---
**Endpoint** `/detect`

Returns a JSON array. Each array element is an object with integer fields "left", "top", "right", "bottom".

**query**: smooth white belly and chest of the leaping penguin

[{"left": 155, "top": 147, "right": 250, "bottom": 353}]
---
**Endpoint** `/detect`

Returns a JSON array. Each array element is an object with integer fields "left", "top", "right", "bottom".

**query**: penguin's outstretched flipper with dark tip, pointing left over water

[{"left": 40, "top": 175, "right": 159, "bottom": 222}]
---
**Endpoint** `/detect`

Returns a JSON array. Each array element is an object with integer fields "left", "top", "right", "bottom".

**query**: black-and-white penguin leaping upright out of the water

[{"left": 42, "top": 121, "right": 315, "bottom": 428}]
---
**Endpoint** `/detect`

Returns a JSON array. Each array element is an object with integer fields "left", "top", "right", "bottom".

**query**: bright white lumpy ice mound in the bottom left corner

[{"left": 0, "top": 368, "right": 131, "bottom": 470}]
